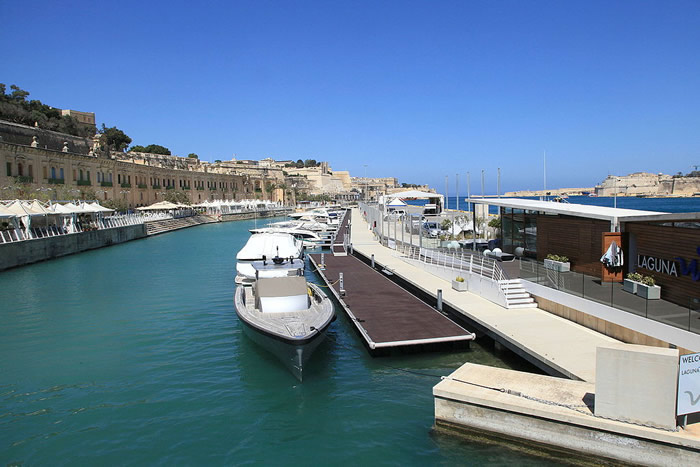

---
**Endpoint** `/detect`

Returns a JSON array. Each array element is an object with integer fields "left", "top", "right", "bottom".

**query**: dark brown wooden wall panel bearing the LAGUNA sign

[{"left": 625, "top": 223, "right": 700, "bottom": 307}]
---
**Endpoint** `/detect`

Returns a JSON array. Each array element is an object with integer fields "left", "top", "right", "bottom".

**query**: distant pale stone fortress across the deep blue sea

[{"left": 505, "top": 172, "right": 700, "bottom": 197}]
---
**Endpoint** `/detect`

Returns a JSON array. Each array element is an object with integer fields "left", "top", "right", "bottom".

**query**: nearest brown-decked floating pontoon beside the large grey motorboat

[{"left": 309, "top": 252, "right": 474, "bottom": 353}]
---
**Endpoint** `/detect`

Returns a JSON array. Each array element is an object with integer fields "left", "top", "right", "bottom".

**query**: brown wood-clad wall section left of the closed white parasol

[{"left": 537, "top": 215, "right": 610, "bottom": 277}]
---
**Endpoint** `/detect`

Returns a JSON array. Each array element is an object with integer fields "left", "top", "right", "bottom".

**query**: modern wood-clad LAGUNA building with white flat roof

[{"left": 469, "top": 198, "right": 700, "bottom": 342}]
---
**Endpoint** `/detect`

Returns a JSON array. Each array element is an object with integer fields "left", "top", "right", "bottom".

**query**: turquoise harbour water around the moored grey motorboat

[{"left": 0, "top": 221, "right": 549, "bottom": 465}]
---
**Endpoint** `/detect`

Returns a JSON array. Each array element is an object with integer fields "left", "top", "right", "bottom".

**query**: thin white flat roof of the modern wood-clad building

[{"left": 466, "top": 198, "right": 670, "bottom": 222}]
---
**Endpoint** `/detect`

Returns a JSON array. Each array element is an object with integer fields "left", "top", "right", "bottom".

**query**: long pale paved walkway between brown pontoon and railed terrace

[{"left": 351, "top": 209, "right": 618, "bottom": 382}]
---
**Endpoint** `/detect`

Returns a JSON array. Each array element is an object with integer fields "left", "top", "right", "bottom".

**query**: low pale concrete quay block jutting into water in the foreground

[{"left": 433, "top": 363, "right": 700, "bottom": 466}]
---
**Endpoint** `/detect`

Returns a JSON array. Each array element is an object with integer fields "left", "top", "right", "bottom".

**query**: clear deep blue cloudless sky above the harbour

[{"left": 0, "top": 0, "right": 700, "bottom": 193}]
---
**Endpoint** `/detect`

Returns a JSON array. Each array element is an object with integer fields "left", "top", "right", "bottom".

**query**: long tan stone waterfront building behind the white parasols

[{"left": 0, "top": 121, "right": 295, "bottom": 208}]
